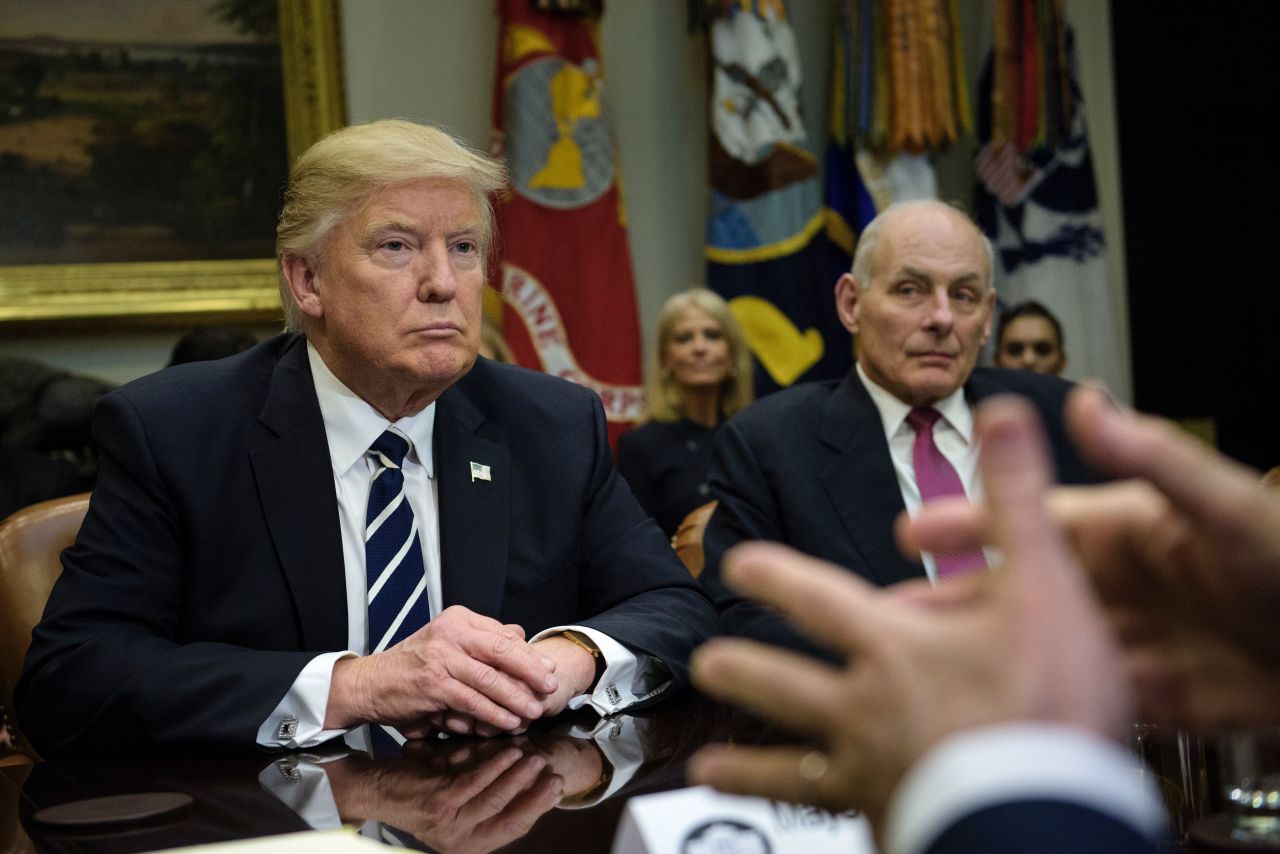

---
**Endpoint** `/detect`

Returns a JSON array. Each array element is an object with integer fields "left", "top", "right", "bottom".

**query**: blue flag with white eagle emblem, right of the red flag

[{"left": 707, "top": 0, "right": 852, "bottom": 394}]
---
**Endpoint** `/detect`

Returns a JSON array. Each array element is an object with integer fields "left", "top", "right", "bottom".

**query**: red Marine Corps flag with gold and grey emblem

[{"left": 494, "top": 0, "right": 644, "bottom": 440}]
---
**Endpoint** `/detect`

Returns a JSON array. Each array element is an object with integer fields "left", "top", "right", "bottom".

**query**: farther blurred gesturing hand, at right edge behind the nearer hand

[{"left": 901, "top": 388, "right": 1280, "bottom": 726}]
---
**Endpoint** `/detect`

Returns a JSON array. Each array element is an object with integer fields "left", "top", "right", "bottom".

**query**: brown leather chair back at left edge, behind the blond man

[{"left": 0, "top": 493, "right": 88, "bottom": 755}]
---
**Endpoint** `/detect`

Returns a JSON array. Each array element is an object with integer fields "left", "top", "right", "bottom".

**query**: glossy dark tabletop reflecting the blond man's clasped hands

[{"left": 8, "top": 697, "right": 728, "bottom": 853}]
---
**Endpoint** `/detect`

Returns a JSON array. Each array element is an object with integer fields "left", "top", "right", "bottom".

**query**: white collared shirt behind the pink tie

[{"left": 855, "top": 364, "right": 998, "bottom": 584}]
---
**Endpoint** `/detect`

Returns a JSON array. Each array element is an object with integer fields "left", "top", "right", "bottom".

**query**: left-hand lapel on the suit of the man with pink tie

[{"left": 819, "top": 371, "right": 924, "bottom": 585}]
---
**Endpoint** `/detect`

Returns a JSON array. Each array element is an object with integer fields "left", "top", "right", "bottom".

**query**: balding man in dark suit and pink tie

[{"left": 703, "top": 201, "right": 1096, "bottom": 652}]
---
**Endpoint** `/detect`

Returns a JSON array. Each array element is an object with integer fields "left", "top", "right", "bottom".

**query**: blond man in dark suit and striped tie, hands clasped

[{"left": 18, "top": 120, "right": 714, "bottom": 755}]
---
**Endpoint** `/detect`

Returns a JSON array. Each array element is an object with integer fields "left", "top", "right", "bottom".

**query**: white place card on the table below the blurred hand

[{"left": 613, "top": 786, "right": 876, "bottom": 854}]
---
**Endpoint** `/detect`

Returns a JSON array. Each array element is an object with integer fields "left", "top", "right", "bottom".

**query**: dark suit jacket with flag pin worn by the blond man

[{"left": 17, "top": 334, "right": 716, "bottom": 754}]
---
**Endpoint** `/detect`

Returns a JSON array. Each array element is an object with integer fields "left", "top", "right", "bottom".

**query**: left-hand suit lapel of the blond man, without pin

[{"left": 250, "top": 338, "right": 347, "bottom": 650}]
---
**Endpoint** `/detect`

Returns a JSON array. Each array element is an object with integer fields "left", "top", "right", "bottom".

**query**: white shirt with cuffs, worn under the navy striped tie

[{"left": 257, "top": 342, "right": 671, "bottom": 749}]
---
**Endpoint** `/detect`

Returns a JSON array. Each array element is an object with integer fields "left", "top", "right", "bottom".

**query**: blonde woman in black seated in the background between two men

[{"left": 618, "top": 288, "right": 753, "bottom": 536}]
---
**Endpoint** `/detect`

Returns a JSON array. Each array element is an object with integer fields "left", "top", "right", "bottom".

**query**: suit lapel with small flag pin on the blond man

[{"left": 435, "top": 376, "right": 512, "bottom": 618}]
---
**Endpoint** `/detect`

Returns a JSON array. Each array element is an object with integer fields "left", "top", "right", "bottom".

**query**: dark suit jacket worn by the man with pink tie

[{"left": 701, "top": 367, "right": 1097, "bottom": 652}]
